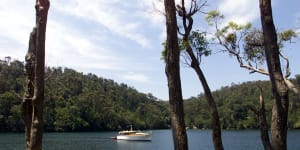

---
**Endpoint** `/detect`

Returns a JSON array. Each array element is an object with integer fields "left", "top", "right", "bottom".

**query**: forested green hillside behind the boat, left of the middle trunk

[{"left": 0, "top": 58, "right": 170, "bottom": 131}]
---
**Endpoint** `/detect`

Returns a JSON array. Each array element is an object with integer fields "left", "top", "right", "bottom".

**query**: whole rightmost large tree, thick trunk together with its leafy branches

[{"left": 206, "top": 0, "right": 299, "bottom": 149}]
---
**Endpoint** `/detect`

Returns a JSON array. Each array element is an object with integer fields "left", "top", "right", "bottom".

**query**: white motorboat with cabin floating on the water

[{"left": 116, "top": 126, "right": 151, "bottom": 141}]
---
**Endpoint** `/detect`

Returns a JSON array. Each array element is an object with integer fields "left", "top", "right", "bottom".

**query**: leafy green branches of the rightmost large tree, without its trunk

[{"left": 206, "top": 11, "right": 299, "bottom": 94}]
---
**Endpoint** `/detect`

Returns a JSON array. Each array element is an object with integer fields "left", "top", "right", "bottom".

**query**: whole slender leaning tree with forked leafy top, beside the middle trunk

[{"left": 177, "top": 0, "right": 224, "bottom": 150}]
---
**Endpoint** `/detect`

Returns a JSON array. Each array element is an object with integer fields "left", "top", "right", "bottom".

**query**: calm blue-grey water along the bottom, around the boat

[{"left": 0, "top": 130, "right": 300, "bottom": 150}]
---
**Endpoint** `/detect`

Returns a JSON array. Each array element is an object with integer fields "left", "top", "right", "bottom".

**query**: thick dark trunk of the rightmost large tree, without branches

[{"left": 259, "top": 0, "right": 289, "bottom": 150}]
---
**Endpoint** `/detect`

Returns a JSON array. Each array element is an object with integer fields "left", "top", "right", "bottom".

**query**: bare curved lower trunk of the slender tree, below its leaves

[{"left": 187, "top": 46, "right": 224, "bottom": 150}]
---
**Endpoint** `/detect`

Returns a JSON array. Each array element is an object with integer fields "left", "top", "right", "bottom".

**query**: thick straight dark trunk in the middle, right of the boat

[{"left": 164, "top": 0, "right": 188, "bottom": 150}]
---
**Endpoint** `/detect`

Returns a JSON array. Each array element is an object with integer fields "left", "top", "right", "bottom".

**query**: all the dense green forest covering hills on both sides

[{"left": 0, "top": 60, "right": 300, "bottom": 132}]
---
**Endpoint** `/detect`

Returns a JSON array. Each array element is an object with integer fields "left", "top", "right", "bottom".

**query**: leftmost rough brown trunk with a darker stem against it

[{"left": 22, "top": 0, "right": 50, "bottom": 150}]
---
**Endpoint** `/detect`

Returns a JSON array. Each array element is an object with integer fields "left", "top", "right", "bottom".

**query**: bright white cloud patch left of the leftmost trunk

[{"left": 0, "top": 0, "right": 35, "bottom": 60}]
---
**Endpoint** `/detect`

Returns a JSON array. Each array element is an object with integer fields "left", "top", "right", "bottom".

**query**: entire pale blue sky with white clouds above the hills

[{"left": 0, "top": 0, "right": 300, "bottom": 100}]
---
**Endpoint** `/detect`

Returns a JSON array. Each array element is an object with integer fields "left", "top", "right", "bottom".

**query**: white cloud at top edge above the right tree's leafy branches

[{"left": 218, "top": 0, "right": 259, "bottom": 24}]
